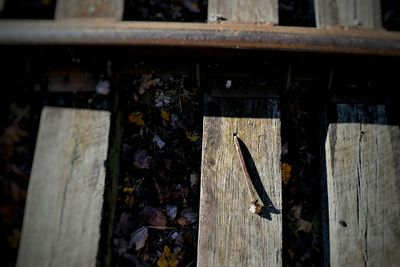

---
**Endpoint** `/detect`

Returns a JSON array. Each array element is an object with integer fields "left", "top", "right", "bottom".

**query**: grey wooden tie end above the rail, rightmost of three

[{"left": 315, "top": 0, "right": 382, "bottom": 28}]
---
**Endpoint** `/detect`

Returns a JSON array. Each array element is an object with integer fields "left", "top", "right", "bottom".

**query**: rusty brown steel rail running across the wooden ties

[{"left": 0, "top": 19, "right": 400, "bottom": 56}]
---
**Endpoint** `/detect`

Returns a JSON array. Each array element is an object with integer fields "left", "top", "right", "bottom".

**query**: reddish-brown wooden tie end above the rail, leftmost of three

[{"left": 56, "top": 0, "right": 124, "bottom": 20}]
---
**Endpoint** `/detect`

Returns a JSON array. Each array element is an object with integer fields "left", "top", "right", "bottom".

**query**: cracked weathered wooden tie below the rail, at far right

[{"left": 325, "top": 104, "right": 400, "bottom": 267}]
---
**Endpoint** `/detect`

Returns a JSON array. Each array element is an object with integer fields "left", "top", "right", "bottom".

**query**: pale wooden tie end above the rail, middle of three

[{"left": 208, "top": 0, "right": 279, "bottom": 24}]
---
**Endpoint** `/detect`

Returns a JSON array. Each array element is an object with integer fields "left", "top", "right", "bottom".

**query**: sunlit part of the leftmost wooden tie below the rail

[{"left": 17, "top": 107, "right": 110, "bottom": 267}]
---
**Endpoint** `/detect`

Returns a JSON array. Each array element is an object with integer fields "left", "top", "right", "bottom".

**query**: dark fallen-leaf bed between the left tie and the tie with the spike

[{"left": 113, "top": 74, "right": 202, "bottom": 266}]
